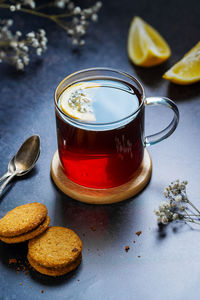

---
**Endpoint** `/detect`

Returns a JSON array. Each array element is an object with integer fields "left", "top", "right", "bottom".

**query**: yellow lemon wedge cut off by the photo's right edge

[{"left": 163, "top": 42, "right": 200, "bottom": 84}]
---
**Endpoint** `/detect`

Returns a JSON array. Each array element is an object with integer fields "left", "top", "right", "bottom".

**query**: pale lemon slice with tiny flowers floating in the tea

[{"left": 60, "top": 83, "right": 97, "bottom": 121}]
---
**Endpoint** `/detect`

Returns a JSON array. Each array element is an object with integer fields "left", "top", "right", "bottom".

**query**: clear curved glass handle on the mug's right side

[{"left": 144, "top": 97, "right": 179, "bottom": 146}]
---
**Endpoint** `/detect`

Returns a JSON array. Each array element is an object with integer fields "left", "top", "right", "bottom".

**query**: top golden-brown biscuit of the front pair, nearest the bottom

[{"left": 28, "top": 226, "right": 82, "bottom": 268}]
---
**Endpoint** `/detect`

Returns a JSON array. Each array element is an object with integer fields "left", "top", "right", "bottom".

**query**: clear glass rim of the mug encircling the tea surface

[{"left": 54, "top": 67, "right": 145, "bottom": 128}]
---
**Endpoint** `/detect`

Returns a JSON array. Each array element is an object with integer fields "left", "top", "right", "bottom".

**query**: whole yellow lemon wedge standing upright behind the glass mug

[{"left": 128, "top": 17, "right": 171, "bottom": 67}]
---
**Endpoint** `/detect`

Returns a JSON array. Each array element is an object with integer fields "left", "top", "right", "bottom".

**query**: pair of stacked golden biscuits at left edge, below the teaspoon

[{"left": 0, "top": 202, "right": 50, "bottom": 244}]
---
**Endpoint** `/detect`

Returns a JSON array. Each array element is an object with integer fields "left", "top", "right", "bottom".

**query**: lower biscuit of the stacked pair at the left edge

[{"left": 0, "top": 216, "right": 50, "bottom": 244}]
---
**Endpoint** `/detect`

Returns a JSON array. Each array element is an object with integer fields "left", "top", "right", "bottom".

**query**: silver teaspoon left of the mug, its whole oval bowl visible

[{"left": 0, "top": 135, "right": 40, "bottom": 195}]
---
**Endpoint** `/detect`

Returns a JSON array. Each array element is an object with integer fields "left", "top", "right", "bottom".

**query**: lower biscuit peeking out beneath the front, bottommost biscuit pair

[{"left": 27, "top": 254, "right": 82, "bottom": 276}]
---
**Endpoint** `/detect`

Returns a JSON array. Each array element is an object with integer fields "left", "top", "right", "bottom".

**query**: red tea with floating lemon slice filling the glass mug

[{"left": 56, "top": 78, "right": 144, "bottom": 188}]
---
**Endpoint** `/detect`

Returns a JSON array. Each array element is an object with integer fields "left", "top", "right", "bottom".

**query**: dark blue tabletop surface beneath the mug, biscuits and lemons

[{"left": 0, "top": 0, "right": 200, "bottom": 300}]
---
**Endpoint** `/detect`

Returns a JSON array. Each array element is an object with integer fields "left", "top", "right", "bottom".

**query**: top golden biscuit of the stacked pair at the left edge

[{"left": 0, "top": 202, "right": 47, "bottom": 237}]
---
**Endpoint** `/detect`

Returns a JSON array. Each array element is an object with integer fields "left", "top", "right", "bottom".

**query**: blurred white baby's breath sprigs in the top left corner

[{"left": 0, "top": 0, "right": 102, "bottom": 70}]
